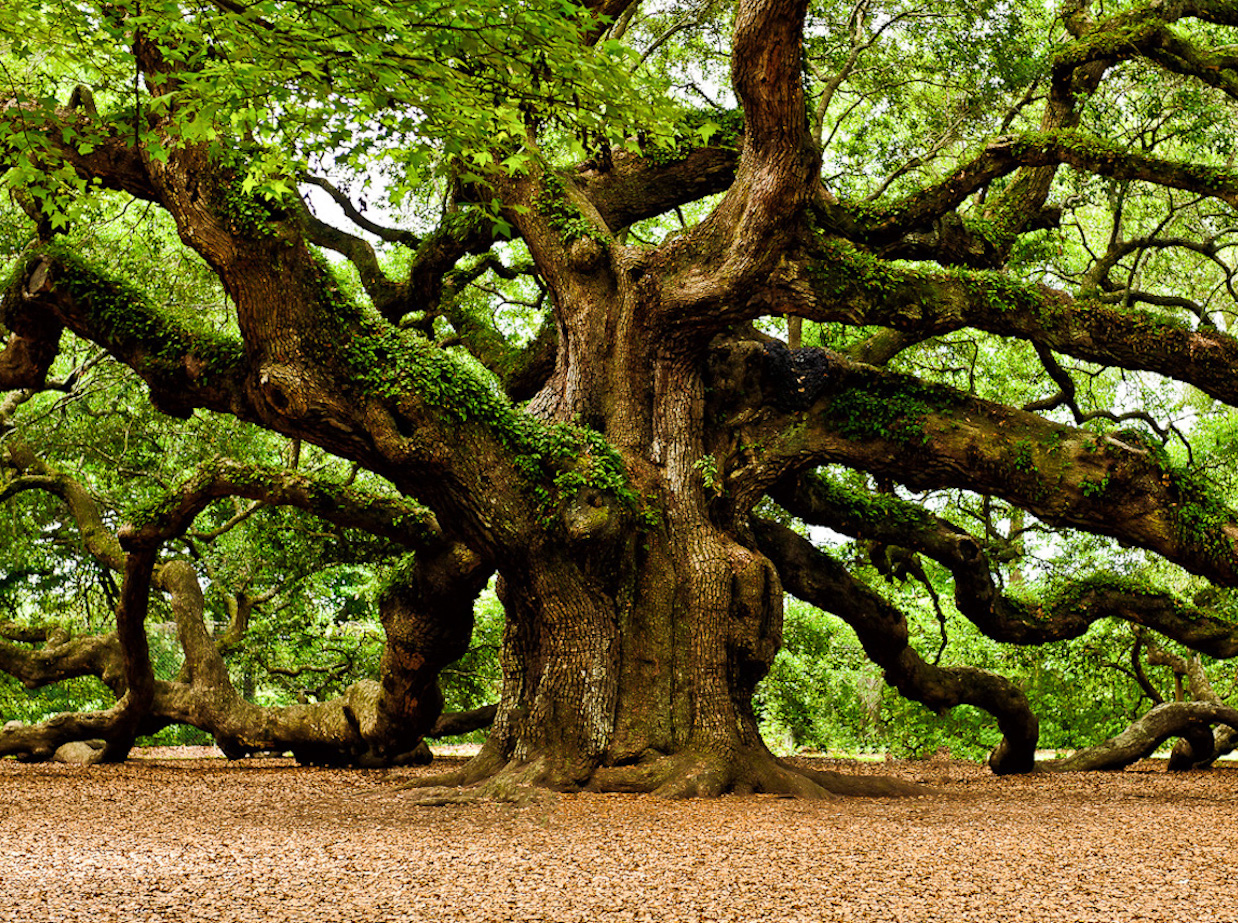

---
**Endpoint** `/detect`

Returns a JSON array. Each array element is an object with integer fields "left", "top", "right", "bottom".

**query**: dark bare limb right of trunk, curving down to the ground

[{"left": 753, "top": 520, "right": 1040, "bottom": 773}]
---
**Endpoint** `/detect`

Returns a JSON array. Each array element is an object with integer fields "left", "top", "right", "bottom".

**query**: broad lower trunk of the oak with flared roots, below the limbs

[{"left": 418, "top": 522, "right": 924, "bottom": 801}]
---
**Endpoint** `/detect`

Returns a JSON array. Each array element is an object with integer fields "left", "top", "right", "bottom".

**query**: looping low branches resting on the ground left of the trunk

[{"left": 0, "top": 443, "right": 490, "bottom": 765}]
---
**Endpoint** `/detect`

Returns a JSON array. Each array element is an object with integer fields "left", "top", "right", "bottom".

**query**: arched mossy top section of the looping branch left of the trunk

[{"left": 126, "top": 458, "right": 444, "bottom": 548}]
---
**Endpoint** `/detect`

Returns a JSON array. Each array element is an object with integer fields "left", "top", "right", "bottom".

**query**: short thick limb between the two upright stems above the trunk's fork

[{"left": 577, "top": 139, "right": 739, "bottom": 233}]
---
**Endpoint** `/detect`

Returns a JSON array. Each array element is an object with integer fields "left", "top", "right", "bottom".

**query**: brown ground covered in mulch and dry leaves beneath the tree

[{"left": 0, "top": 751, "right": 1238, "bottom": 923}]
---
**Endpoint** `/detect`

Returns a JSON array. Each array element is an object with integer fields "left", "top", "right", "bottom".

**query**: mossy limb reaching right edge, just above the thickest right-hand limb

[{"left": 802, "top": 241, "right": 1238, "bottom": 406}]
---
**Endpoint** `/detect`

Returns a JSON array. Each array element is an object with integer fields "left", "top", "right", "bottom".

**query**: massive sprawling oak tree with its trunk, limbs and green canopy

[{"left": 0, "top": 0, "right": 1238, "bottom": 796}]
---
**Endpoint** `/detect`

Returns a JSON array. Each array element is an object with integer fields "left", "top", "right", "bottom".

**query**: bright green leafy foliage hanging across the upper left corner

[{"left": 0, "top": 0, "right": 665, "bottom": 226}]
